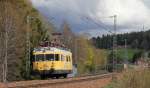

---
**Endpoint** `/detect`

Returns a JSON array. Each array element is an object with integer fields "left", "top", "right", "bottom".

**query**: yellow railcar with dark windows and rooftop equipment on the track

[{"left": 32, "top": 47, "right": 72, "bottom": 78}]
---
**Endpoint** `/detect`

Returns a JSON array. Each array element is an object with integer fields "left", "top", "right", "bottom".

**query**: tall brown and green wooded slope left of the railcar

[{"left": 0, "top": 0, "right": 53, "bottom": 81}]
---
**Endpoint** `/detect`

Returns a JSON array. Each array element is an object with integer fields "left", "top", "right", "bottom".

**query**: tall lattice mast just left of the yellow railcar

[{"left": 26, "top": 16, "right": 31, "bottom": 78}]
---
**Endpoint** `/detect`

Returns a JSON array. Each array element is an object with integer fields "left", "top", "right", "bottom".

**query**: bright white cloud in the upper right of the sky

[{"left": 97, "top": 0, "right": 150, "bottom": 25}]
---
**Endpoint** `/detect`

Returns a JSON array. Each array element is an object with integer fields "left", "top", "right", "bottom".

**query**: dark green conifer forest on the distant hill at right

[{"left": 92, "top": 30, "right": 150, "bottom": 50}]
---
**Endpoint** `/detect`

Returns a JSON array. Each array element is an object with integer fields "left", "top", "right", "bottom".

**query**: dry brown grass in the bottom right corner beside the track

[{"left": 114, "top": 69, "right": 150, "bottom": 88}]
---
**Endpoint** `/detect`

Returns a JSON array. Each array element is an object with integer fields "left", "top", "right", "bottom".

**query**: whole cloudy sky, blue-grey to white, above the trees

[{"left": 31, "top": 0, "right": 150, "bottom": 36}]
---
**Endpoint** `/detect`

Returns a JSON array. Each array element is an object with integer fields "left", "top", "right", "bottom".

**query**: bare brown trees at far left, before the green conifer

[{"left": 0, "top": 0, "right": 24, "bottom": 81}]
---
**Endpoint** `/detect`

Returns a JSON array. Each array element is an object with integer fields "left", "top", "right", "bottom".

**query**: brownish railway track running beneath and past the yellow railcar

[{"left": 6, "top": 73, "right": 114, "bottom": 88}]
